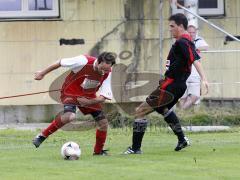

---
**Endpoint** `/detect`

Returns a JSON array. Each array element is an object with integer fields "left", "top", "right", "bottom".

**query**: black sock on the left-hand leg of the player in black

[{"left": 132, "top": 119, "right": 147, "bottom": 151}]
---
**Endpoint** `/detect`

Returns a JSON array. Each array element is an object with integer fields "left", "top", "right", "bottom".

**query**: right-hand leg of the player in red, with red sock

[{"left": 90, "top": 110, "right": 108, "bottom": 155}]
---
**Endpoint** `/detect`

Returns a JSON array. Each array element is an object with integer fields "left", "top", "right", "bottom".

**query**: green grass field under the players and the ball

[{"left": 0, "top": 129, "right": 240, "bottom": 180}]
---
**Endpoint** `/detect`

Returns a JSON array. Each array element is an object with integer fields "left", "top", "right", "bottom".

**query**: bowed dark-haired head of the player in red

[{"left": 97, "top": 52, "right": 116, "bottom": 73}]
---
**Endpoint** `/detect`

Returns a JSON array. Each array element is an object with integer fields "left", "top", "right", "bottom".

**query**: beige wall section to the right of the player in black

[{"left": 197, "top": 0, "right": 240, "bottom": 98}]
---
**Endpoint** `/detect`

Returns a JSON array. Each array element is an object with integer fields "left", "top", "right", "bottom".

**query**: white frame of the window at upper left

[{"left": 0, "top": 0, "right": 60, "bottom": 20}]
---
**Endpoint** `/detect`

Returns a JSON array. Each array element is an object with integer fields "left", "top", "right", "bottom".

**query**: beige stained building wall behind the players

[{"left": 0, "top": 0, "right": 240, "bottom": 105}]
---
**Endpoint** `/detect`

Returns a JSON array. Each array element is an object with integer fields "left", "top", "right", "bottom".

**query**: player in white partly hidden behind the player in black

[{"left": 180, "top": 25, "right": 208, "bottom": 109}]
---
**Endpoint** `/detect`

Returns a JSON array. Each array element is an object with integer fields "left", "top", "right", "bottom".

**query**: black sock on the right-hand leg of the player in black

[{"left": 164, "top": 111, "right": 185, "bottom": 141}]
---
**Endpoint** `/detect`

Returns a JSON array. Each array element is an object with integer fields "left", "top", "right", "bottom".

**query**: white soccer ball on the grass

[{"left": 61, "top": 141, "right": 81, "bottom": 160}]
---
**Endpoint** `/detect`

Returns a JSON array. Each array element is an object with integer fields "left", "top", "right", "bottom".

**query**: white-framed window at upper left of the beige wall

[{"left": 0, "top": 0, "right": 59, "bottom": 19}]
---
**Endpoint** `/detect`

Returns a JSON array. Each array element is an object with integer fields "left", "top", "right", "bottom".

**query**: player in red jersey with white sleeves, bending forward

[{"left": 33, "top": 52, "right": 116, "bottom": 155}]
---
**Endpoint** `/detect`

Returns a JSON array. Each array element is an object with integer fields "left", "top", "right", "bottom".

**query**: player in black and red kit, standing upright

[{"left": 124, "top": 13, "right": 208, "bottom": 154}]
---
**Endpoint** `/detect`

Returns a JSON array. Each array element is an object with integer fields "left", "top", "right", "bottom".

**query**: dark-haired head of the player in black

[{"left": 168, "top": 13, "right": 188, "bottom": 39}]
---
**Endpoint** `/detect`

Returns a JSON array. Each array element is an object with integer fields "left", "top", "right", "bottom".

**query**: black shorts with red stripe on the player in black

[{"left": 146, "top": 78, "right": 187, "bottom": 114}]
